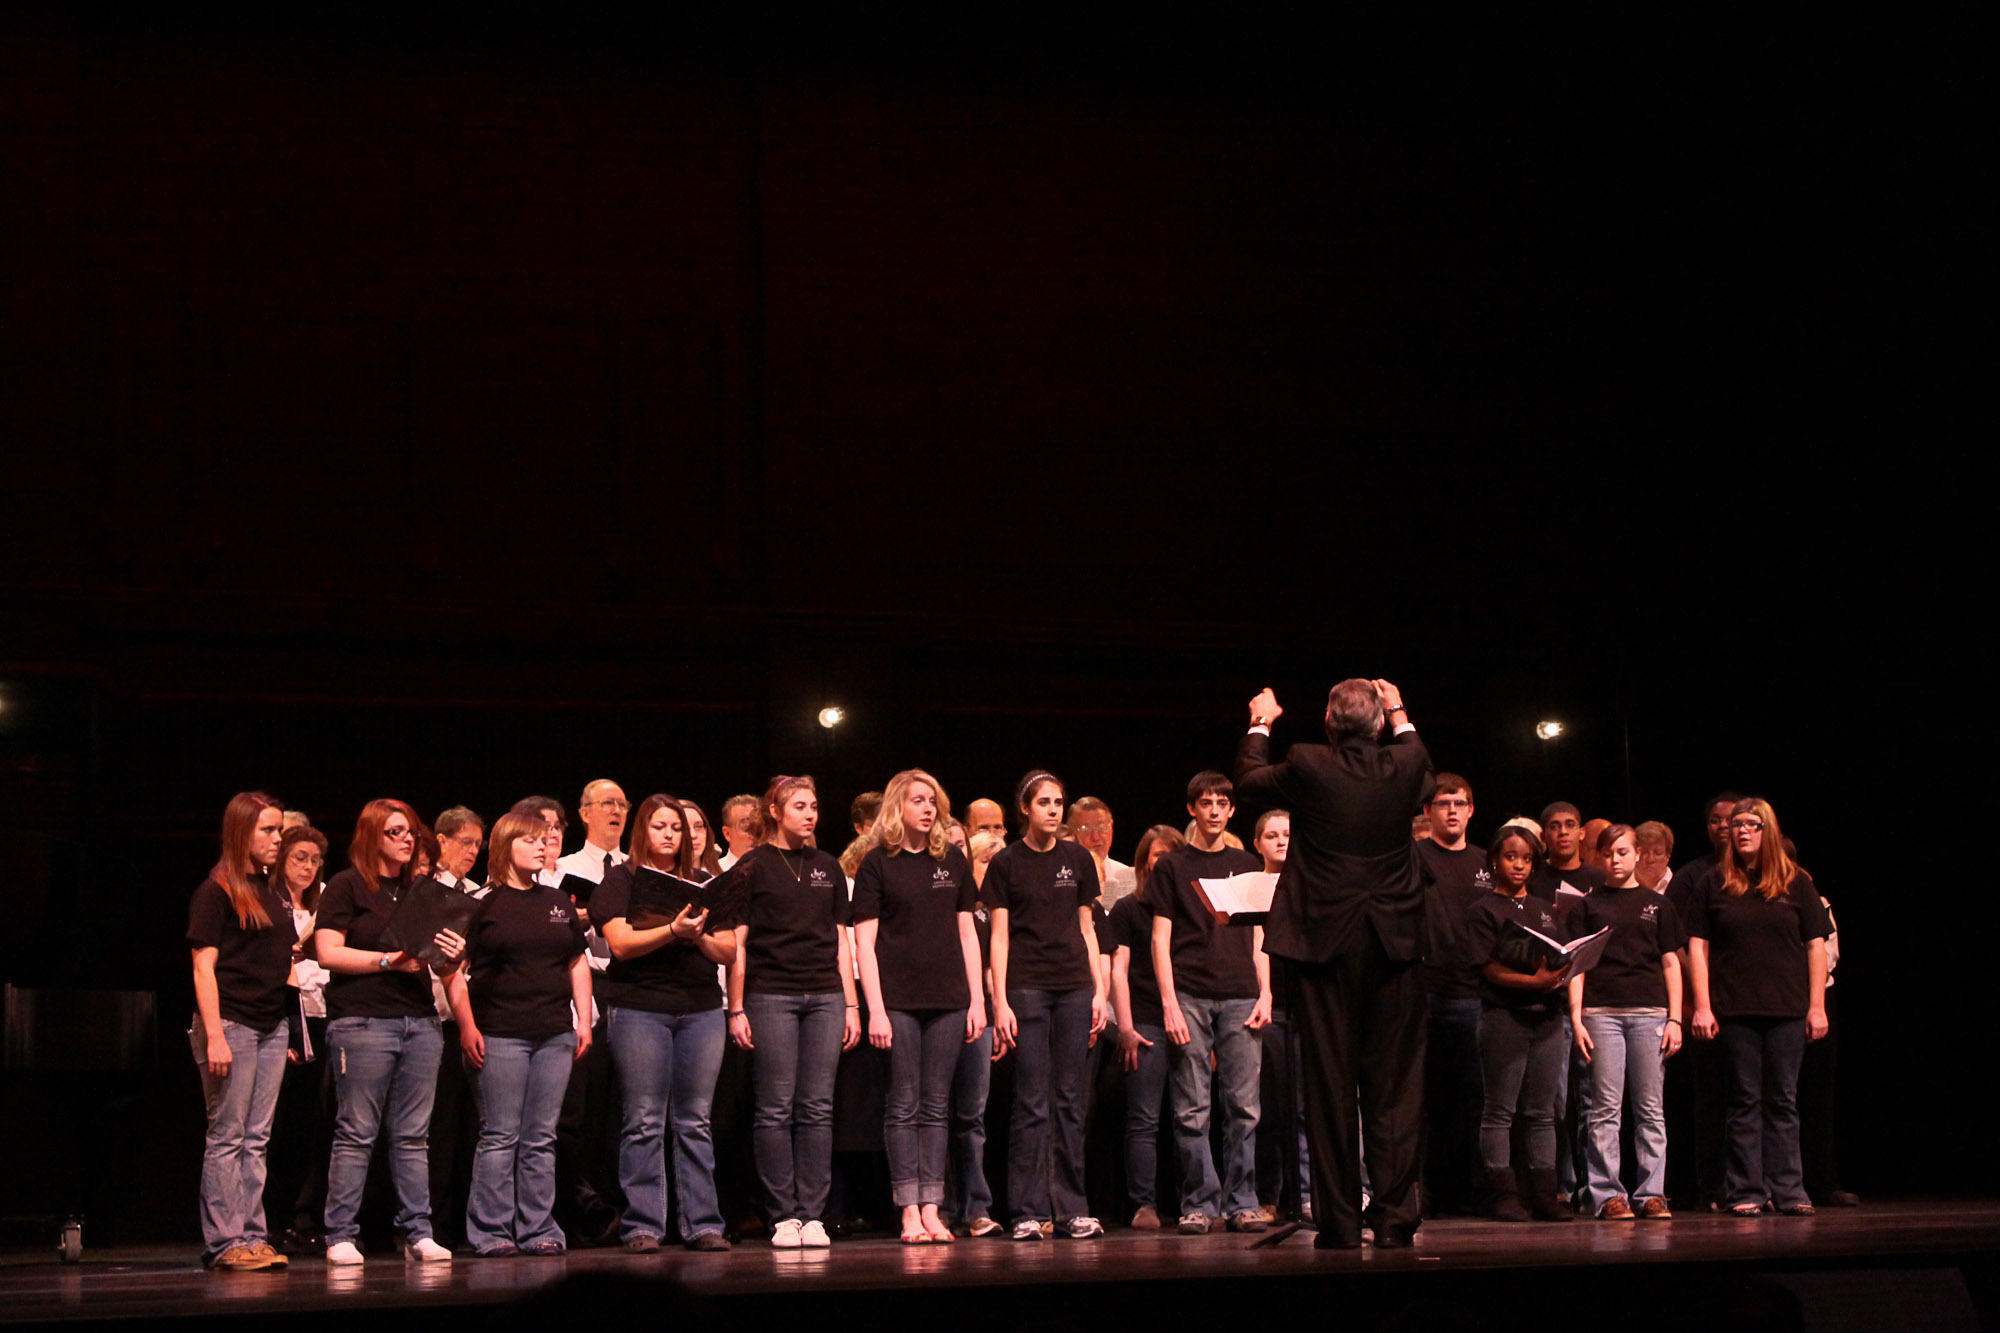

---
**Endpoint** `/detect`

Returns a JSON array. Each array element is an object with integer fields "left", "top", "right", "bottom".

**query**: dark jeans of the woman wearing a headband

[{"left": 1006, "top": 987, "right": 1094, "bottom": 1223}]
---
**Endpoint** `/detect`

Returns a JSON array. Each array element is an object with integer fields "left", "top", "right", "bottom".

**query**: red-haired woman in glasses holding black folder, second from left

[{"left": 314, "top": 801, "right": 466, "bottom": 1267}]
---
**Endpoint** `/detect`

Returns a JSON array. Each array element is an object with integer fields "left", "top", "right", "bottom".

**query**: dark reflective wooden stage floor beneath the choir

[{"left": 0, "top": 1199, "right": 2000, "bottom": 1333}]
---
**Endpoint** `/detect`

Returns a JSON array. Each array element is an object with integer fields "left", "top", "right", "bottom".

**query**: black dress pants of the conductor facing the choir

[{"left": 1292, "top": 931, "right": 1424, "bottom": 1245}]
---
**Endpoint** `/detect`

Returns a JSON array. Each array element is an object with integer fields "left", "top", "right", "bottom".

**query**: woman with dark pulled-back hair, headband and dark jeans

[{"left": 984, "top": 769, "right": 1110, "bottom": 1241}]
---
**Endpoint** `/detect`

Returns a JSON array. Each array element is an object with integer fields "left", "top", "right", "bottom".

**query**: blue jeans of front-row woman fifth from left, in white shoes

[{"left": 744, "top": 991, "right": 846, "bottom": 1223}]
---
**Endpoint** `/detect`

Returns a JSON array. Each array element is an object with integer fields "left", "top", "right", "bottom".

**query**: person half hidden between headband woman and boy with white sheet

[{"left": 1104, "top": 825, "right": 1188, "bottom": 1231}]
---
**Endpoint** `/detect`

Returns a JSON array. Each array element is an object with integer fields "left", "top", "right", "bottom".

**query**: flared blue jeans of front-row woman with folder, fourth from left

[{"left": 606, "top": 1005, "right": 736, "bottom": 1241}]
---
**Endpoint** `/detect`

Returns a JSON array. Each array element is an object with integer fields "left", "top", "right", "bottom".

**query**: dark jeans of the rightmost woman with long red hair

[{"left": 1716, "top": 1019, "right": 1812, "bottom": 1209}]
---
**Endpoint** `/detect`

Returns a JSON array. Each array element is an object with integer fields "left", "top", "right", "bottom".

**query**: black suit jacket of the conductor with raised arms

[{"left": 1236, "top": 731, "right": 1436, "bottom": 963}]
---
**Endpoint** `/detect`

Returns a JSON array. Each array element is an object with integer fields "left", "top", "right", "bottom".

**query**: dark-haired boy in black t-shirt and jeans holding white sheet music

[{"left": 1146, "top": 773, "right": 1270, "bottom": 1235}]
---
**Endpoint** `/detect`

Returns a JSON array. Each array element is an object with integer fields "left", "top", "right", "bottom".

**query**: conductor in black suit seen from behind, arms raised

[{"left": 1236, "top": 681, "right": 1434, "bottom": 1249}]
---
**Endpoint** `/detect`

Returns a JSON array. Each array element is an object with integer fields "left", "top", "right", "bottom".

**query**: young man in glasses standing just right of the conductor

[{"left": 1416, "top": 773, "right": 1494, "bottom": 1217}]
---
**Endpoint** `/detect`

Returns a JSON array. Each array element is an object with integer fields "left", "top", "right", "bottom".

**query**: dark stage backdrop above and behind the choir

[{"left": 0, "top": 4, "right": 1976, "bottom": 1237}]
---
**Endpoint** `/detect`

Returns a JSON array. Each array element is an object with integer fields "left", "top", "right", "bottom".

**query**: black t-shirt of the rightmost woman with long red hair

[{"left": 1688, "top": 871, "right": 1832, "bottom": 1019}]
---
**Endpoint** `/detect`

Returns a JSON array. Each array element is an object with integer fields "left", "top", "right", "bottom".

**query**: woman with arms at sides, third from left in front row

[{"left": 446, "top": 813, "right": 590, "bottom": 1259}]
